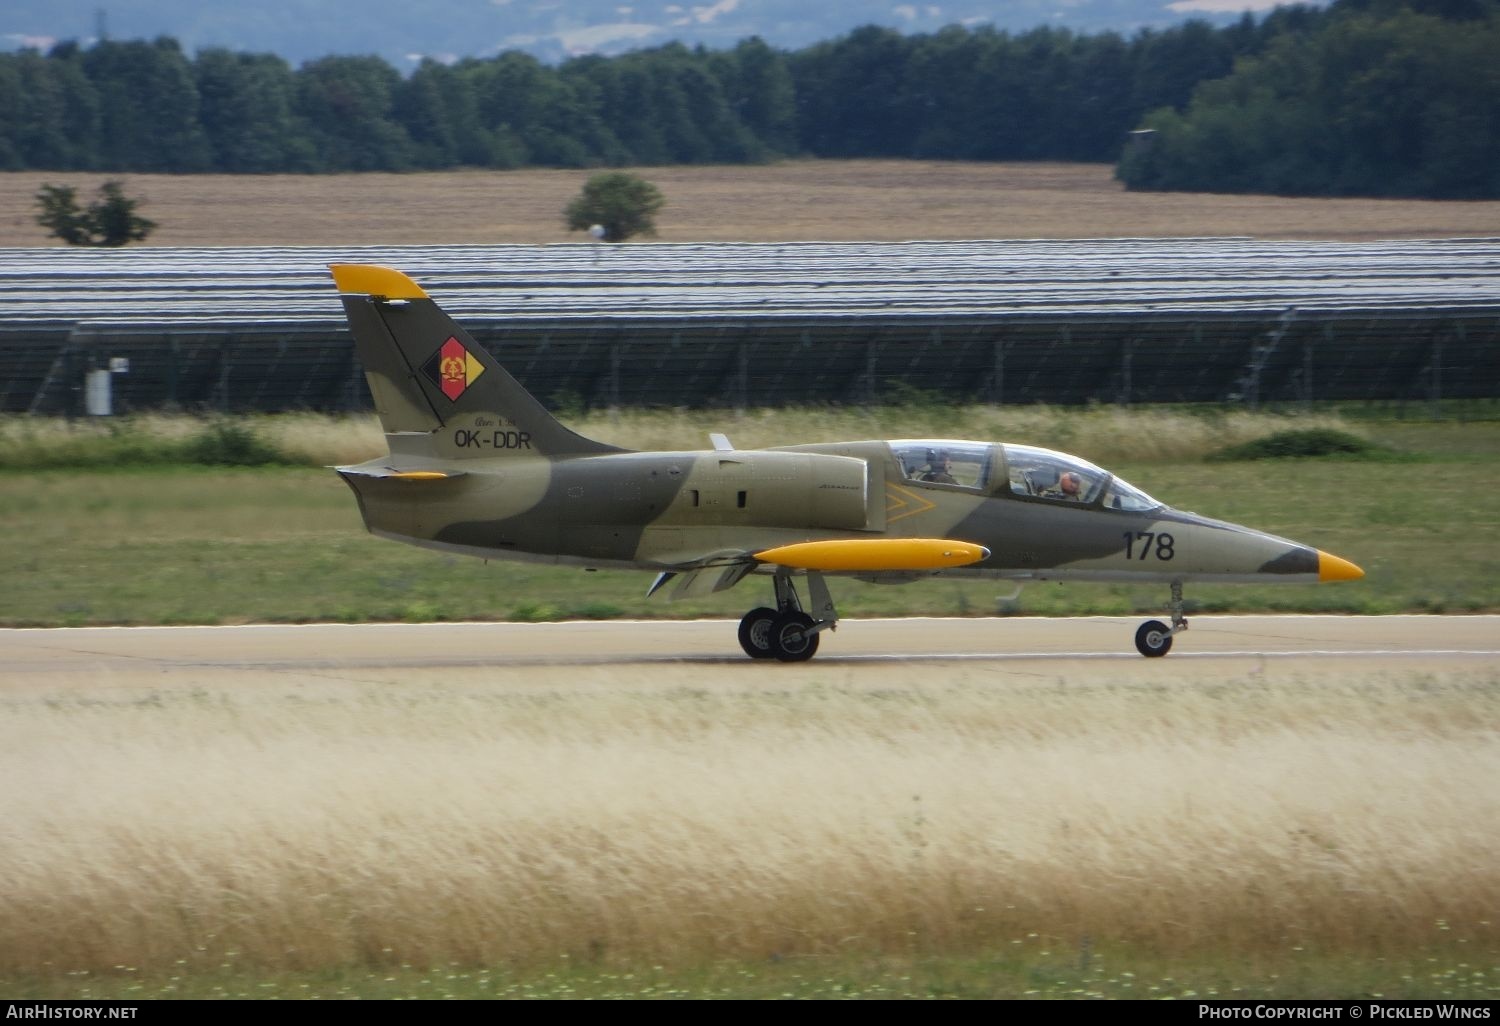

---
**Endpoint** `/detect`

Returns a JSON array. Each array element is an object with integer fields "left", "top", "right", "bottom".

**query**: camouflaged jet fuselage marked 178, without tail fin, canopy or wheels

[{"left": 345, "top": 428, "right": 1344, "bottom": 581}]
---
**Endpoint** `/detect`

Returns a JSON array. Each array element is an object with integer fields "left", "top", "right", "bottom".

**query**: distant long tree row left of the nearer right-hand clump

[{"left": 0, "top": 9, "right": 1319, "bottom": 173}]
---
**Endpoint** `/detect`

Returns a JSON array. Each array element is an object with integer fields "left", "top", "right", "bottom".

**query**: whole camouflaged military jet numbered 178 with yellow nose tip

[{"left": 332, "top": 264, "right": 1364, "bottom": 662}]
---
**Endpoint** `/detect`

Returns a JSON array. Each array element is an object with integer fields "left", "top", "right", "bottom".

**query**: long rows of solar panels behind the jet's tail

[{"left": 0, "top": 239, "right": 1500, "bottom": 413}]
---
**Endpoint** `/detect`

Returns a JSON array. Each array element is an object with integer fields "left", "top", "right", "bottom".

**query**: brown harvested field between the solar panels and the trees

[{"left": 0, "top": 161, "right": 1500, "bottom": 246}]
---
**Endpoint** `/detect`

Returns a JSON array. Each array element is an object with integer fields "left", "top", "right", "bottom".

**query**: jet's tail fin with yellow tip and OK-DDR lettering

[{"left": 329, "top": 264, "right": 620, "bottom": 459}]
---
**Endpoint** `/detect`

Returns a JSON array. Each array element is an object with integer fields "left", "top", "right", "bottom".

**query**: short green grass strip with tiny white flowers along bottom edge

[{"left": 0, "top": 935, "right": 1500, "bottom": 1001}]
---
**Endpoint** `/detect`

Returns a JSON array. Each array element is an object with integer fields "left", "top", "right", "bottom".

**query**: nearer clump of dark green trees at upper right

[{"left": 1116, "top": 0, "right": 1500, "bottom": 200}]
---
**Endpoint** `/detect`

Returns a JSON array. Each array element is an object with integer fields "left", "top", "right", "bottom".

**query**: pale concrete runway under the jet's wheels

[{"left": 0, "top": 617, "right": 1500, "bottom": 692}]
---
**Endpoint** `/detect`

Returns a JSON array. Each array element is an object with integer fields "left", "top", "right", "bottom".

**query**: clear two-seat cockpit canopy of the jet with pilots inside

[{"left": 891, "top": 438, "right": 1161, "bottom": 513}]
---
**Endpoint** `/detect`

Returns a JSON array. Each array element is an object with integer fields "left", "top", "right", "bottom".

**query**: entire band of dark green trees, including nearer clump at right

[{"left": 0, "top": 0, "right": 1500, "bottom": 195}]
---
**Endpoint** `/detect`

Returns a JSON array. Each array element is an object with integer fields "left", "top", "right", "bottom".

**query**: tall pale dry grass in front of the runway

[{"left": 0, "top": 663, "right": 1500, "bottom": 996}]
